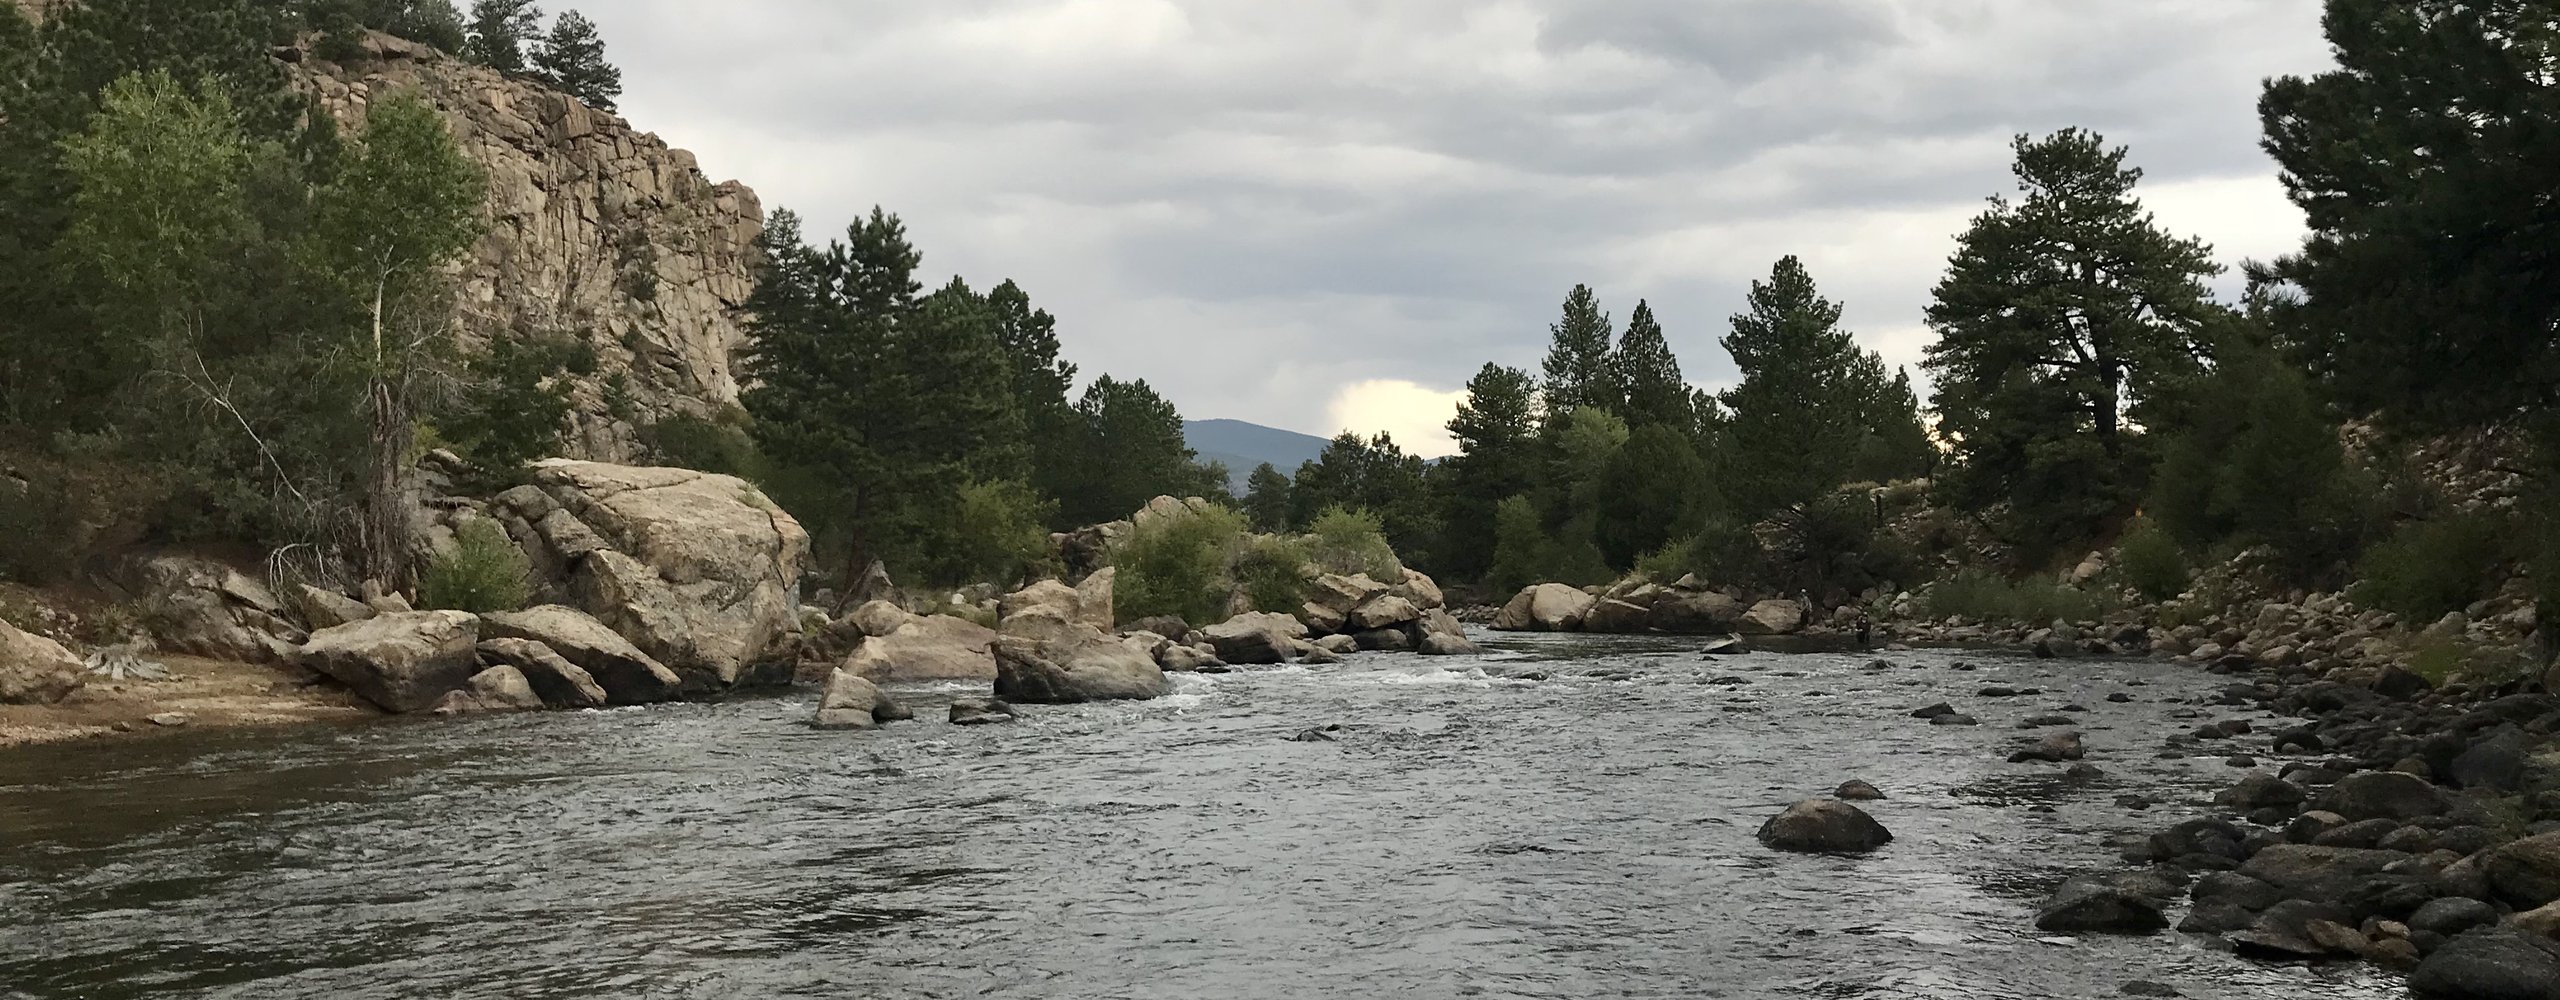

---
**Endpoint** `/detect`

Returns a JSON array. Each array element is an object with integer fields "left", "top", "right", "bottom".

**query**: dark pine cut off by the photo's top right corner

[{"left": 2258, "top": 0, "right": 2560, "bottom": 445}]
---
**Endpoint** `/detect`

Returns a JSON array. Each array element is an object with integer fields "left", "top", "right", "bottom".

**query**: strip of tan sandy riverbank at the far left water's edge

[{"left": 0, "top": 655, "right": 381, "bottom": 747}]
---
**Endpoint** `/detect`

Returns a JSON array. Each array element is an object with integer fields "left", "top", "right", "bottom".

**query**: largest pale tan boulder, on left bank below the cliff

[{"left": 492, "top": 460, "right": 809, "bottom": 691}]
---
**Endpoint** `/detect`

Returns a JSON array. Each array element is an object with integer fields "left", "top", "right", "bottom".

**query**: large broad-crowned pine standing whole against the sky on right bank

[{"left": 1923, "top": 128, "right": 2225, "bottom": 552}]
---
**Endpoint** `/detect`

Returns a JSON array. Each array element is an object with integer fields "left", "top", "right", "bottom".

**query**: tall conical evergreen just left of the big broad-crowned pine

[{"left": 1723, "top": 256, "right": 1871, "bottom": 522}]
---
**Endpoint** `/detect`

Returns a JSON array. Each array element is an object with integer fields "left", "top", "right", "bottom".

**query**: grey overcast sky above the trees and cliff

[{"left": 576, "top": 0, "right": 2327, "bottom": 455}]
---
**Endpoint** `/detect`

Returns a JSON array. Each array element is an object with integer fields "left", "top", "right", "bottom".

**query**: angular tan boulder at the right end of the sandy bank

[{"left": 302, "top": 611, "right": 481, "bottom": 711}]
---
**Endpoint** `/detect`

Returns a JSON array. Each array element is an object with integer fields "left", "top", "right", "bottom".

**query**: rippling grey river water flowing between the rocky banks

[{"left": 0, "top": 637, "right": 2401, "bottom": 1000}]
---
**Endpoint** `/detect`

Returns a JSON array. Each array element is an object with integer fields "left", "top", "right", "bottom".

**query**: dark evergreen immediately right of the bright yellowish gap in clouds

[{"left": 1436, "top": 363, "right": 1539, "bottom": 581}]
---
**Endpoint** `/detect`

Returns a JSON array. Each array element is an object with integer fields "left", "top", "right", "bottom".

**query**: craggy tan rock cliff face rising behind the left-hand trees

[{"left": 288, "top": 33, "right": 763, "bottom": 463}]
